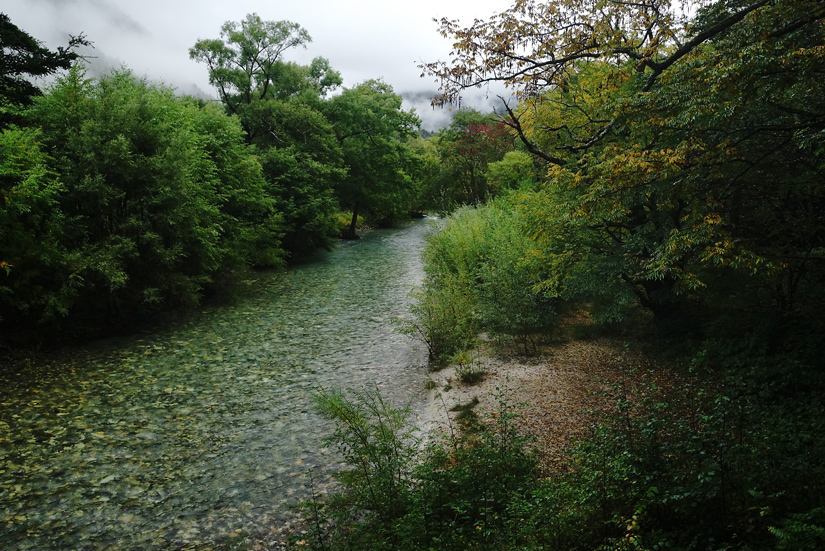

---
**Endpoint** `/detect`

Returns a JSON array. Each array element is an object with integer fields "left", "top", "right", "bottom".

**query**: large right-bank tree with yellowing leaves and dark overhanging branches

[{"left": 426, "top": 0, "right": 825, "bottom": 318}]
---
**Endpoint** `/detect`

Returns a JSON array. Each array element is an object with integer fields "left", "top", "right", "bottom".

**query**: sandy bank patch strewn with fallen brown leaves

[{"left": 420, "top": 332, "right": 663, "bottom": 475}]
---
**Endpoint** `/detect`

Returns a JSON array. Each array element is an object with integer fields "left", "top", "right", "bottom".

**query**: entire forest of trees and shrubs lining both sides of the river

[{"left": 0, "top": 0, "right": 825, "bottom": 551}]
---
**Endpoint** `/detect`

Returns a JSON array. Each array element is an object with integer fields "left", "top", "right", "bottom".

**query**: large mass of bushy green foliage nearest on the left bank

[{"left": 3, "top": 68, "right": 283, "bottom": 332}]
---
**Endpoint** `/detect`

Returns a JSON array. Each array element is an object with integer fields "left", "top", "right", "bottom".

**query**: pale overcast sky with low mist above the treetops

[{"left": 0, "top": 0, "right": 511, "bottom": 130}]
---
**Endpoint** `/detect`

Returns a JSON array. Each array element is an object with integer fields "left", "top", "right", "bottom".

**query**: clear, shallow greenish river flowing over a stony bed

[{"left": 0, "top": 221, "right": 428, "bottom": 551}]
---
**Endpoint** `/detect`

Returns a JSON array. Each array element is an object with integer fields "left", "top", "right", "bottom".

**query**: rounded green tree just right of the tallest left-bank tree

[{"left": 328, "top": 80, "right": 420, "bottom": 239}]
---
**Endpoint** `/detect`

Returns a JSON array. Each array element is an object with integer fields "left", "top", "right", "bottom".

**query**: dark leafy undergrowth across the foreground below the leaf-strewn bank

[{"left": 294, "top": 330, "right": 825, "bottom": 551}]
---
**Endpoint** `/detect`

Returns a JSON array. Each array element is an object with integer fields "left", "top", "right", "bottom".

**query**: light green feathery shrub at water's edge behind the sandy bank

[{"left": 400, "top": 199, "right": 554, "bottom": 358}]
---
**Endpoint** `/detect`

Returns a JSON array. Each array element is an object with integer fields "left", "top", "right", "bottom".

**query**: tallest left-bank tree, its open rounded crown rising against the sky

[{"left": 190, "top": 14, "right": 344, "bottom": 255}]
